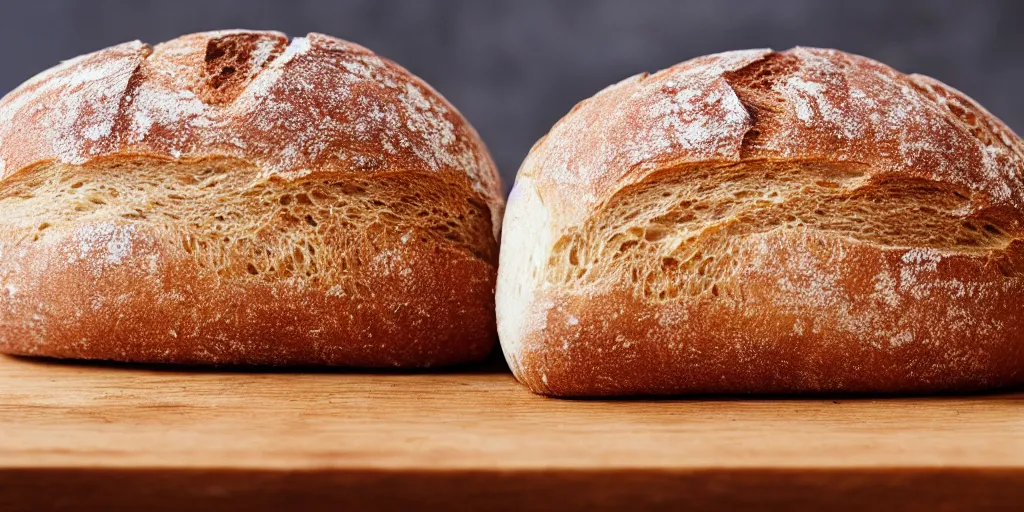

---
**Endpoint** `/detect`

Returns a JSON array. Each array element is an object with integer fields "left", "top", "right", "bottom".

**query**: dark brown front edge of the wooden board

[{"left": 0, "top": 467, "right": 1024, "bottom": 512}]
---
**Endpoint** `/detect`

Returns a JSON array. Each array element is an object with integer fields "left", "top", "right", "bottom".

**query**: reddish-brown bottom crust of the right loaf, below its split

[{"left": 505, "top": 230, "right": 1024, "bottom": 396}]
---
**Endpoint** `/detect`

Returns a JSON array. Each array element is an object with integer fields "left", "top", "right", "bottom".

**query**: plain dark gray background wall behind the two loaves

[{"left": 0, "top": 0, "right": 1024, "bottom": 186}]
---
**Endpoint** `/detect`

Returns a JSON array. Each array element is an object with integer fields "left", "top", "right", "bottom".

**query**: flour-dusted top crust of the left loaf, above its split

[{"left": 0, "top": 31, "right": 503, "bottom": 234}]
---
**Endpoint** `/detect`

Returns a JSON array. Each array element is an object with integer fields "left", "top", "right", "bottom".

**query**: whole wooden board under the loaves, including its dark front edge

[{"left": 0, "top": 356, "right": 1024, "bottom": 511}]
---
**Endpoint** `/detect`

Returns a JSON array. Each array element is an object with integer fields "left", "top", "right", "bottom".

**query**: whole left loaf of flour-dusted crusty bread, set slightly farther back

[{"left": 0, "top": 31, "right": 504, "bottom": 367}]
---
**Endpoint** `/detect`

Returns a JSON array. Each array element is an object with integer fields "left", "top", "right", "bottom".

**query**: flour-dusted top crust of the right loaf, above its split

[{"left": 520, "top": 47, "right": 1024, "bottom": 225}]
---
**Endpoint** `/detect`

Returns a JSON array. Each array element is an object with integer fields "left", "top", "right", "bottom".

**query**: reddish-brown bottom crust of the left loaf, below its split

[{"left": 0, "top": 222, "right": 496, "bottom": 368}]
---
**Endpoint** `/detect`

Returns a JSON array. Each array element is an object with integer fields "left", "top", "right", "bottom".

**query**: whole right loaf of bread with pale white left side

[{"left": 497, "top": 48, "right": 1024, "bottom": 396}]
